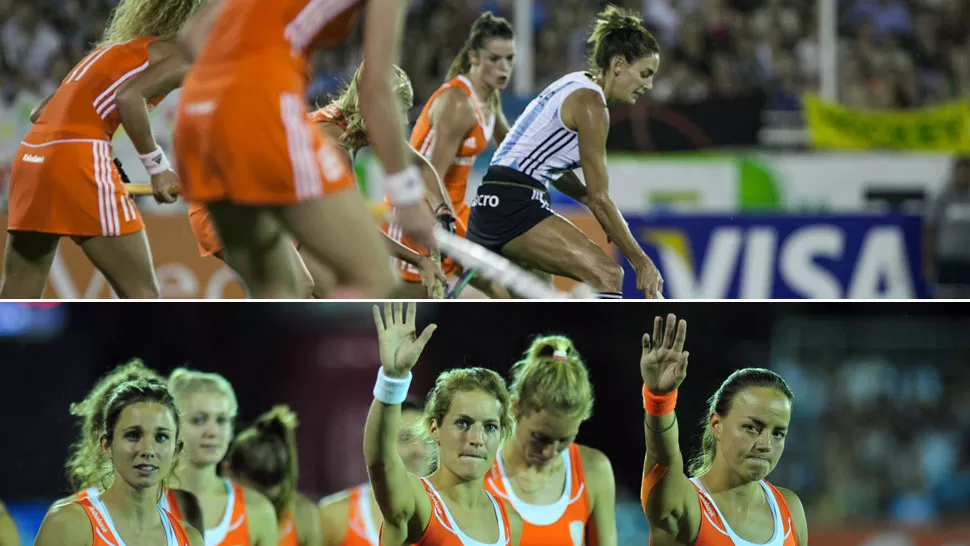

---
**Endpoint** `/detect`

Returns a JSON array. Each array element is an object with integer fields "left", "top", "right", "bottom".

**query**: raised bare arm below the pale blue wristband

[{"left": 364, "top": 388, "right": 431, "bottom": 546}]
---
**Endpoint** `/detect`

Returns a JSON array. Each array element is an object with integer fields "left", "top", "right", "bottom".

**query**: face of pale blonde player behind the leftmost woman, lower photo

[{"left": 179, "top": 391, "right": 232, "bottom": 466}]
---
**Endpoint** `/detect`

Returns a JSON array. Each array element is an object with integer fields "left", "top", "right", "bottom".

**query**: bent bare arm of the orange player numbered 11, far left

[{"left": 115, "top": 42, "right": 190, "bottom": 156}]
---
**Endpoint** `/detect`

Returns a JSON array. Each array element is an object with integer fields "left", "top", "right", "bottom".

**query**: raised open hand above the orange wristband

[{"left": 640, "top": 313, "right": 690, "bottom": 394}]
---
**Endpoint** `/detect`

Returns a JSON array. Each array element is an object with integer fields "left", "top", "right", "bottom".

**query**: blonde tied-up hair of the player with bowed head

[{"left": 509, "top": 336, "right": 593, "bottom": 421}]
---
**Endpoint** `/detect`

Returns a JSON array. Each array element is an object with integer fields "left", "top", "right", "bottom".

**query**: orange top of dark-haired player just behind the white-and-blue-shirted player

[{"left": 411, "top": 76, "right": 495, "bottom": 204}]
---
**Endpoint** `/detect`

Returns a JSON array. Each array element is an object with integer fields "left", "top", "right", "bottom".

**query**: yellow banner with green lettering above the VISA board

[{"left": 802, "top": 95, "right": 970, "bottom": 152}]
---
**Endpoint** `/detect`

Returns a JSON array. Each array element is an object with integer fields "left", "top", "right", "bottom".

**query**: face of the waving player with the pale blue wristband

[{"left": 431, "top": 390, "right": 502, "bottom": 481}]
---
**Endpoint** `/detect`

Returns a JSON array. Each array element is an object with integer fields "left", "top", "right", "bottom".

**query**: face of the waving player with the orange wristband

[{"left": 711, "top": 387, "right": 791, "bottom": 481}]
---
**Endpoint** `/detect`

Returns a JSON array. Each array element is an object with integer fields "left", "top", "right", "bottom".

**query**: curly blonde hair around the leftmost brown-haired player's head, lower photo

[{"left": 64, "top": 358, "right": 165, "bottom": 491}]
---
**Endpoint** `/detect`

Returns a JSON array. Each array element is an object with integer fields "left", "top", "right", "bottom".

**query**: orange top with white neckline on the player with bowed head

[{"left": 485, "top": 444, "right": 590, "bottom": 546}]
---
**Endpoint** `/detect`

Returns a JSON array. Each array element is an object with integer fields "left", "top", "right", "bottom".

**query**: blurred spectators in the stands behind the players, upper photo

[{"left": 0, "top": 0, "right": 970, "bottom": 110}]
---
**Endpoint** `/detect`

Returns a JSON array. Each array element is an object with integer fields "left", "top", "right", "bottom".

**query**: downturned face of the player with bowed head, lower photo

[{"left": 512, "top": 409, "right": 582, "bottom": 466}]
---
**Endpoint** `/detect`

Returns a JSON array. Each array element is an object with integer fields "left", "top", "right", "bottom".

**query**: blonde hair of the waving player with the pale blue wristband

[{"left": 421, "top": 368, "right": 512, "bottom": 450}]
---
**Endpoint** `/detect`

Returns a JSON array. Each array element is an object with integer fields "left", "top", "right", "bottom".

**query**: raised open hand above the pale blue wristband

[{"left": 374, "top": 302, "right": 438, "bottom": 377}]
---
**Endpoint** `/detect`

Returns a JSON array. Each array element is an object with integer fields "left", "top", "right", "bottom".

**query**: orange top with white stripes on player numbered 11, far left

[{"left": 24, "top": 38, "right": 165, "bottom": 144}]
